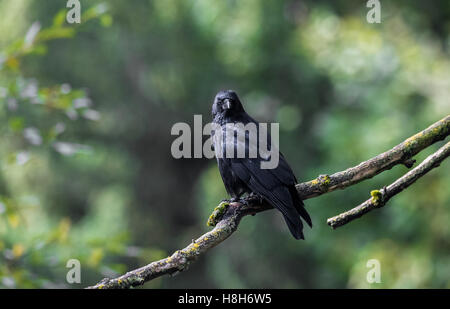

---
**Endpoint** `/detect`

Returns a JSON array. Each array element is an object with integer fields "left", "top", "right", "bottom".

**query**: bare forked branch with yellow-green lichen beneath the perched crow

[{"left": 88, "top": 115, "right": 450, "bottom": 289}]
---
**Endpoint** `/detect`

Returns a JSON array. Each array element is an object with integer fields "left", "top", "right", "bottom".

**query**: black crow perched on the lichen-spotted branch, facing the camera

[{"left": 212, "top": 90, "right": 312, "bottom": 239}]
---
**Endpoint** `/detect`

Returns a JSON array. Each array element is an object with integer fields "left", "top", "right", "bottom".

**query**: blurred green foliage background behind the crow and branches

[{"left": 0, "top": 0, "right": 450, "bottom": 288}]
